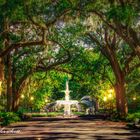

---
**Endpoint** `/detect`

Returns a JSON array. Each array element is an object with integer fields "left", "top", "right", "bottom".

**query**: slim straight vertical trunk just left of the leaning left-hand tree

[{"left": 7, "top": 54, "right": 12, "bottom": 111}]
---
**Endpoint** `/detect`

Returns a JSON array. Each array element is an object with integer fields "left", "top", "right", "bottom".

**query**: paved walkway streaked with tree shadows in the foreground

[{"left": 0, "top": 118, "right": 140, "bottom": 140}]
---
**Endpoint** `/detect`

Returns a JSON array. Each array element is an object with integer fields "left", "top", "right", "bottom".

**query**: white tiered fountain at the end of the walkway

[{"left": 56, "top": 80, "right": 79, "bottom": 116}]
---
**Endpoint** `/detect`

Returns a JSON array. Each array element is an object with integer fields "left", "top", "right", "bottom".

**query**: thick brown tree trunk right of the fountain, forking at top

[{"left": 89, "top": 25, "right": 130, "bottom": 117}]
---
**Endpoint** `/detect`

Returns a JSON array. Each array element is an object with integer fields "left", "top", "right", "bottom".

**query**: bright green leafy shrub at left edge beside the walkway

[{"left": 0, "top": 112, "right": 20, "bottom": 126}]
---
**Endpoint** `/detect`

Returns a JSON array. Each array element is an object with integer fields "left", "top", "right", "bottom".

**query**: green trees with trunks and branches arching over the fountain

[{"left": 0, "top": 0, "right": 140, "bottom": 116}]
